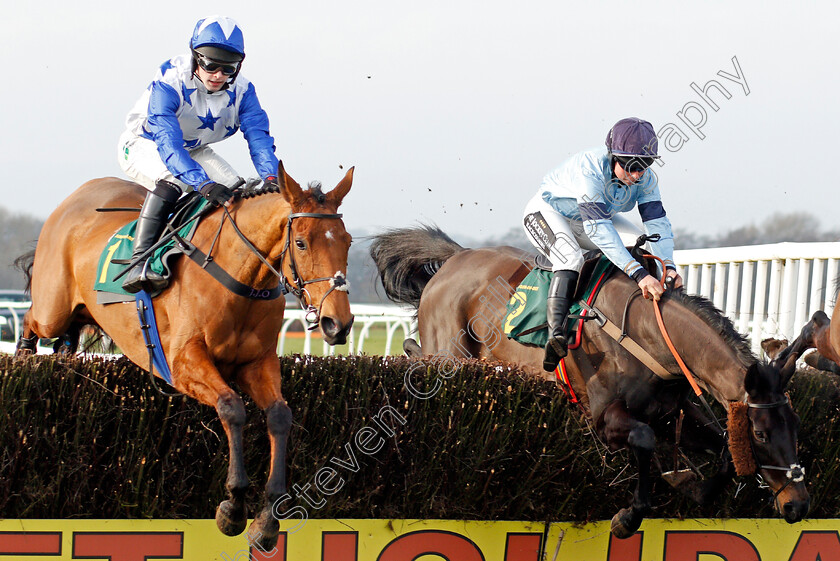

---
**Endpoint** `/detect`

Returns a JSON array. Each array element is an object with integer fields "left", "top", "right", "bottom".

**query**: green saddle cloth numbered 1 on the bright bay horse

[{"left": 93, "top": 199, "right": 207, "bottom": 300}]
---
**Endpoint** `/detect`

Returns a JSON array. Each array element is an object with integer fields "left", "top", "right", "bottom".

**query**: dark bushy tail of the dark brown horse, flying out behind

[{"left": 370, "top": 225, "right": 464, "bottom": 308}]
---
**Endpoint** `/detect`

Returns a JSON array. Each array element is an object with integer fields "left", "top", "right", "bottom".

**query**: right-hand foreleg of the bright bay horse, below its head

[{"left": 237, "top": 350, "right": 292, "bottom": 552}]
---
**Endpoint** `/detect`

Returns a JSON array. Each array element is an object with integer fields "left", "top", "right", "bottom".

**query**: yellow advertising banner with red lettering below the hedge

[{"left": 0, "top": 519, "right": 840, "bottom": 561}]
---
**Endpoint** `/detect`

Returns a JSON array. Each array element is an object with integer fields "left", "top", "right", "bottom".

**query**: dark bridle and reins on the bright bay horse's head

[{"left": 217, "top": 206, "right": 349, "bottom": 331}]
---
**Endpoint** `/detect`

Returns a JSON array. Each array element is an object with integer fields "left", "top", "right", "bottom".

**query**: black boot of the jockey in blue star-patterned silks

[{"left": 123, "top": 182, "right": 181, "bottom": 294}]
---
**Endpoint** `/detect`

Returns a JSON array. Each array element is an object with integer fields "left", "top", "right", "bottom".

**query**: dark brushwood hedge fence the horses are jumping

[{"left": 0, "top": 355, "right": 840, "bottom": 522}]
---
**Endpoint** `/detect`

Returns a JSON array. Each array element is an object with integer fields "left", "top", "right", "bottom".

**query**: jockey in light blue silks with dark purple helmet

[{"left": 524, "top": 118, "right": 682, "bottom": 372}]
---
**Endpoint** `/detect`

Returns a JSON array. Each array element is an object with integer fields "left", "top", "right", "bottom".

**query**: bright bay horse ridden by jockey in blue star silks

[{"left": 17, "top": 163, "right": 353, "bottom": 551}]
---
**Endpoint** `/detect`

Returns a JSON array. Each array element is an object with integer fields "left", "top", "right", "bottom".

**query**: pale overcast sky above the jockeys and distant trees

[{"left": 0, "top": 0, "right": 840, "bottom": 243}]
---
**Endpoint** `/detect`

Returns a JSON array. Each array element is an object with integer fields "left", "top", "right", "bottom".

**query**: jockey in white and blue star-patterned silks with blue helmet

[{"left": 119, "top": 16, "right": 278, "bottom": 293}]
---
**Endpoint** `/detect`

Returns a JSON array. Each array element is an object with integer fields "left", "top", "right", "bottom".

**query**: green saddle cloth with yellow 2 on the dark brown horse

[{"left": 502, "top": 255, "right": 613, "bottom": 347}]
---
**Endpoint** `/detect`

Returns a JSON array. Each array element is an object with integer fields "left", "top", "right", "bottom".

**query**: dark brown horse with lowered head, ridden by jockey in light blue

[{"left": 370, "top": 226, "right": 810, "bottom": 538}]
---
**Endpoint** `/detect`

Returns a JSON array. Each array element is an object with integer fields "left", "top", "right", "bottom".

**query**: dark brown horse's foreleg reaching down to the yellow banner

[{"left": 602, "top": 401, "right": 656, "bottom": 539}]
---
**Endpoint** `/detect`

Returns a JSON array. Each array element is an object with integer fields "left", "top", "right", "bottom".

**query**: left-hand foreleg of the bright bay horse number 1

[{"left": 172, "top": 343, "right": 250, "bottom": 536}]
